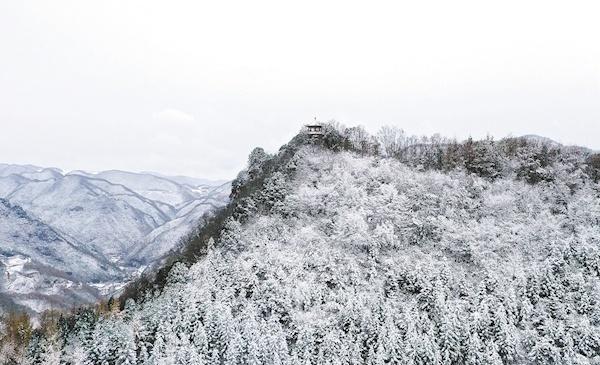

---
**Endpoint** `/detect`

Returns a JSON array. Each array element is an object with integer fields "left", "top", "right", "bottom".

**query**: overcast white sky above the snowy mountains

[{"left": 0, "top": 0, "right": 600, "bottom": 178}]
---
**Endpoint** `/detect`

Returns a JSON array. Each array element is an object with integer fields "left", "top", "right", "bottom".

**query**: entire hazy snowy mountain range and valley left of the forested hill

[{"left": 0, "top": 164, "right": 230, "bottom": 312}]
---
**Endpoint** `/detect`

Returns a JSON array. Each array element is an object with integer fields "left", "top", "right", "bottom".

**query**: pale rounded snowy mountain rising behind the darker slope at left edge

[{"left": 6, "top": 175, "right": 169, "bottom": 261}]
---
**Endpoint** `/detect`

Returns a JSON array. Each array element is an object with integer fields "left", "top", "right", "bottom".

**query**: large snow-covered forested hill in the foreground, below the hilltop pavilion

[{"left": 0, "top": 124, "right": 600, "bottom": 365}]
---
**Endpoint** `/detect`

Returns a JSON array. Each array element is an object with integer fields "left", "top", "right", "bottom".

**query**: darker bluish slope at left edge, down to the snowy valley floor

[{"left": 0, "top": 199, "right": 123, "bottom": 310}]
